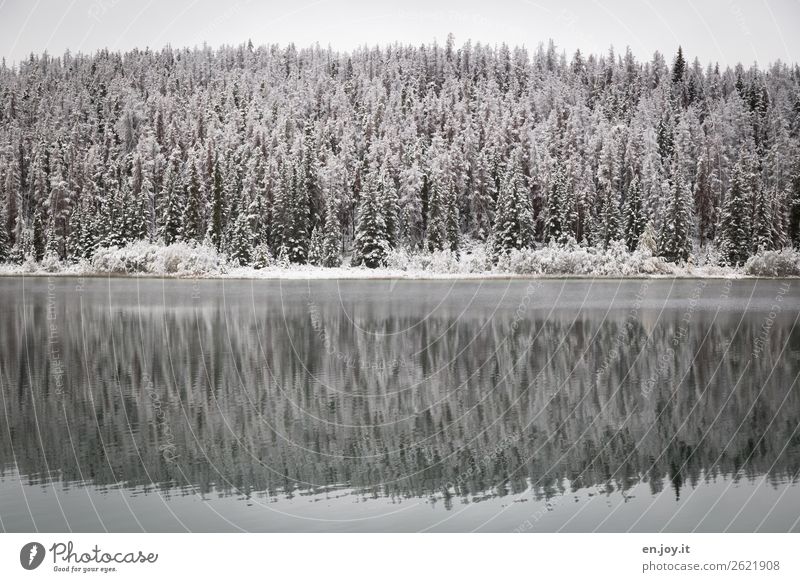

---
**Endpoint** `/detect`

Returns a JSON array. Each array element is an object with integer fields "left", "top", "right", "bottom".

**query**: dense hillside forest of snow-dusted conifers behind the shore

[{"left": 0, "top": 37, "right": 800, "bottom": 267}]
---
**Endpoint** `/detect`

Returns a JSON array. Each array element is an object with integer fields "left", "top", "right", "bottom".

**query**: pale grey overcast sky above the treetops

[{"left": 0, "top": 0, "right": 800, "bottom": 66}]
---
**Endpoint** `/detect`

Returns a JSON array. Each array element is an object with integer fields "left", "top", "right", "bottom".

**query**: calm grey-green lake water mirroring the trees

[{"left": 0, "top": 278, "right": 800, "bottom": 531}]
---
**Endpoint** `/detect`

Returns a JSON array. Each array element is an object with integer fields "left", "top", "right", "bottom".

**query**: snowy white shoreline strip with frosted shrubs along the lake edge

[{"left": 0, "top": 241, "right": 800, "bottom": 279}]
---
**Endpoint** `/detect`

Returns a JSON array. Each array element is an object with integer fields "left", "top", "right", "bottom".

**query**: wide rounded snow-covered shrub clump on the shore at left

[{"left": 91, "top": 241, "right": 224, "bottom": 275}]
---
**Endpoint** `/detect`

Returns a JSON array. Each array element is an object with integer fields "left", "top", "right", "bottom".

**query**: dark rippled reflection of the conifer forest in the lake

[{"left": 0, "top": 280, "right": 800, "bottom": 508}]
